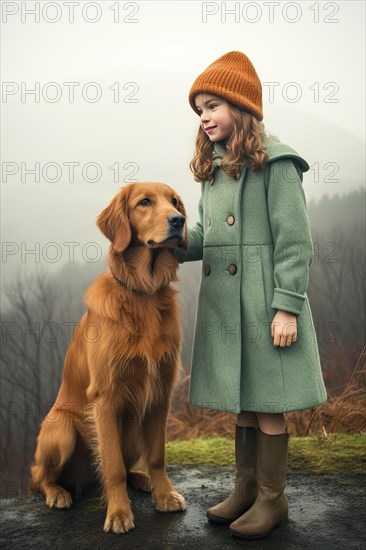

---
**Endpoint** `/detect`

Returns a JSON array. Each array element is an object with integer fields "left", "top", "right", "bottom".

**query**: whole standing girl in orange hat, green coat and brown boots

[{"left": 179, "top": 51, "right": 327, "bottom": 538}]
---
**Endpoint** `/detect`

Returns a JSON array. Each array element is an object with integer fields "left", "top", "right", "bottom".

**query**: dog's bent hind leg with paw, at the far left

[{"left": 30, "top": 407, "right": 76, "bottom": 508}]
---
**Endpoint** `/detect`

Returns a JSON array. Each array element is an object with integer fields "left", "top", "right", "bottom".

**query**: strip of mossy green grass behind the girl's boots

[{"left": 166, "top": 433, "right": 366, "bottom": 474}]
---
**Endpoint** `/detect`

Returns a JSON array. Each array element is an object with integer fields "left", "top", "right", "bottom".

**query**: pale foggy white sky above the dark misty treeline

[{"left": 1, "top": 0, "right": 365, "bottom": 279}]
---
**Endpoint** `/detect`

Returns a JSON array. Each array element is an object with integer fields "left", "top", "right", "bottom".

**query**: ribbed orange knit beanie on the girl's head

[{"left": 189, "top": 52, "right": 263, "bottom": 121}]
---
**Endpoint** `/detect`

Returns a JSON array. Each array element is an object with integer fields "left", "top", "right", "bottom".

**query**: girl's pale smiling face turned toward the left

[{"left": 195, "top": 93, "right": 234, "bottom": 141}]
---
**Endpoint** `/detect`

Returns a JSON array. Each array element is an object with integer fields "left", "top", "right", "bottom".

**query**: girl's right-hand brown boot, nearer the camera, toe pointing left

[{"left": 230, "top": 428, "right": 289, "bottom": 539}]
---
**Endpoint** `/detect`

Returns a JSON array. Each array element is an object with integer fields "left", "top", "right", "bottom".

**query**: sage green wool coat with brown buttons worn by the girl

[{"left": 178, "top": 136, "right": 327, "bottom": 413}]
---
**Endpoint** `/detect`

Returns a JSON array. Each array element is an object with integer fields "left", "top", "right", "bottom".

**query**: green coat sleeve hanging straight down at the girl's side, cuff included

[{"left": 267, "top": 159, "right": 314, "bottom": 315}]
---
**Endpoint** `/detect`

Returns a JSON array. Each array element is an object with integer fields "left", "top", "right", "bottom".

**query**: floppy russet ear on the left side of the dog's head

[{"left": 97, "top": 187, "right": 132, "bottom": 252}]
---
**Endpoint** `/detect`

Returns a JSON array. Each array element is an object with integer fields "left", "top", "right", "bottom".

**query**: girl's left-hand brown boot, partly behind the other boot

[{"left": 207, "top": 426, "right": 258, "bottom": 523}]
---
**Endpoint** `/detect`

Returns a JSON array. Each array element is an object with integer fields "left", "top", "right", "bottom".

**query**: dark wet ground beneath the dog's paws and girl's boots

[{"left": 0, "top": 466, "right": 366, "bottom": 550}]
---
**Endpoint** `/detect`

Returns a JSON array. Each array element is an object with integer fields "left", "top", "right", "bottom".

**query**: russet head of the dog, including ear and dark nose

[{"left": 97, "top": 183, "right": 188, "bottom": 252}]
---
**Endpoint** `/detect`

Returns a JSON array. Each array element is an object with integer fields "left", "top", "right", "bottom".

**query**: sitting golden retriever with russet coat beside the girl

[{"left": 31, "top": 183, "right": 187, "bottom": 533}]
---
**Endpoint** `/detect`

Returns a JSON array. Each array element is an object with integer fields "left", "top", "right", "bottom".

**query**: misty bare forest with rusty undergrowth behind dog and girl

[{"left": 1, "top": 189, "right": 366, "bottom": 492}]
